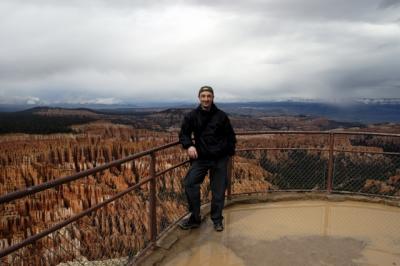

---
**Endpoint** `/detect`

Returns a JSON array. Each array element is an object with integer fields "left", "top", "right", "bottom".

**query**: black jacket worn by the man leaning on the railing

[{"left": 179, "top": 104, "right": 236, "bottom": 159}]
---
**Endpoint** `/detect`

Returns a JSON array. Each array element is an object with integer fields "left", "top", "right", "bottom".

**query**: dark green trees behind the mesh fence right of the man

[{"left": 250, "top": 150, "right": 400, "bottom": 195}]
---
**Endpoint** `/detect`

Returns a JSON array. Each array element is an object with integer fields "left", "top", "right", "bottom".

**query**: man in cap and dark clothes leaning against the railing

[{"left": 179, "top": 86, "right": 236, "bottom": 232}]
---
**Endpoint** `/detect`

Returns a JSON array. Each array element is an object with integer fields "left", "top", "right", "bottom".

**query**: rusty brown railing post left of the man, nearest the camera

[{"left": 149, "top": 152, "right": 157, "bottom": 243}]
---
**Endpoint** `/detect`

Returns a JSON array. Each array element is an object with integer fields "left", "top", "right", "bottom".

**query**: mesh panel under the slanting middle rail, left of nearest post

[{"left": 2, "top": 181, "right": 150, "bottom": 265}]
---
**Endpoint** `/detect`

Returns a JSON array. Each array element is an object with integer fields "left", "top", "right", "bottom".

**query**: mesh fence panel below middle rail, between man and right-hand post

[{"left": 232, "top": 150, "right": 328, "bottom": 194}]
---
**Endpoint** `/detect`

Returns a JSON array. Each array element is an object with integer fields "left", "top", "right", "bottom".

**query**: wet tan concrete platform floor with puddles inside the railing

[{"left": 159, "top": 200, "right": 400, "bottom": 266}]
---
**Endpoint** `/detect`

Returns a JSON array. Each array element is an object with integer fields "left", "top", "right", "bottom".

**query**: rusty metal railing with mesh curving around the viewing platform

[{"left": 0, "top": 131, "right": 400, "bottom": 265}]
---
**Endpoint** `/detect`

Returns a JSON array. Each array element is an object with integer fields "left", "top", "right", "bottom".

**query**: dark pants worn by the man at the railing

[{"left": 184, "top": 156, "right": 229, "bottom": 223}]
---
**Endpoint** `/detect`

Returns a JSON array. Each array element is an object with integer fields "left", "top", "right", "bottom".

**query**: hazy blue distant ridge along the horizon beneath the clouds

[{"left": 0, "top": 98, "right": 400, "bottom": 124}]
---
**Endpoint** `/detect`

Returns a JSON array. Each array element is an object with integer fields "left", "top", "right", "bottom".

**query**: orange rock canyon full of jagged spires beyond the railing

[{"left": 0, "top": 107, "right": 400, "bottom": 265}]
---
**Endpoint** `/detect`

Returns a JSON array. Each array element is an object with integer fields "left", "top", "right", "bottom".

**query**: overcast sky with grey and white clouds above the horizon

[{"left": 0, "top": 0, "right": 400, "bottom": 103}]
